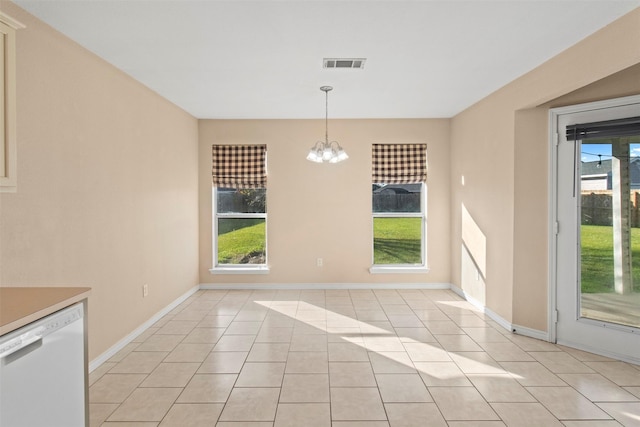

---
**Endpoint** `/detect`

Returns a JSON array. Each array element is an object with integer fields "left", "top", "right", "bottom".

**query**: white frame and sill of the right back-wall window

[{"left": 369, "top": 182, "right": 429, "bottom": 274}]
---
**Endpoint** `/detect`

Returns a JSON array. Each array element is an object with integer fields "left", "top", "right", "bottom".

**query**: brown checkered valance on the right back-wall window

[{"left": 372, "top": 144, "right": 427, "bottom": 184}]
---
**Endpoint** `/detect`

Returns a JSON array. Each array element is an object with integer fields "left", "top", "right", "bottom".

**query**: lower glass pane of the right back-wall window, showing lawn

[{"left": 373, "top": 218, "right": 422, "bottom": 264}]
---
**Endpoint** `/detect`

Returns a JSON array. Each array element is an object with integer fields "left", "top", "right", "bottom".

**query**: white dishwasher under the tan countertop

[{"left": 0, "top": 303, "right": 87, "bottom": 427}]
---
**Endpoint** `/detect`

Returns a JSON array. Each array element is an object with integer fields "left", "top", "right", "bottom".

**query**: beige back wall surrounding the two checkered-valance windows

[{"left": 200, "top": 119, "right": 449, "bottom": 284}]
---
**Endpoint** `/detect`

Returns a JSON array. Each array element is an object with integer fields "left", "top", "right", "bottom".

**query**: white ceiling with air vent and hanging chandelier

[{"left": 14, "top": 0, "right": 640, "bottom": 118}]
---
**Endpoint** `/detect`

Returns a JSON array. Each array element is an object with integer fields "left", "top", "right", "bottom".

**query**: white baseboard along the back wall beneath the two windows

[{"left": 200, "top": 283, "right": 451, "bottom": 290}]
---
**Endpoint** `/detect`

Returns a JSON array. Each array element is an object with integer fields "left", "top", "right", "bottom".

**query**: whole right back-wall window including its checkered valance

[{"left": 371, "top": 144, "right": 427, "bottom": 273}]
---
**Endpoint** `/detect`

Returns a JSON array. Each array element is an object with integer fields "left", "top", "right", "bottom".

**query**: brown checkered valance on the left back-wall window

[{"left": 212, "top": 145, "right": 267, "bottom": 188}]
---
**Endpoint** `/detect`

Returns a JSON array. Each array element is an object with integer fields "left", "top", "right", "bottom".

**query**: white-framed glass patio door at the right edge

[{"left": 552, "top": 97, "right": 640, "bottom": 363}]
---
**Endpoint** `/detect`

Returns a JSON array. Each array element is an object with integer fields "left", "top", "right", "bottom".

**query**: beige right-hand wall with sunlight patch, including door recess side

[{"left": 451, "top": 9, "right": 640, "bottom": 331}]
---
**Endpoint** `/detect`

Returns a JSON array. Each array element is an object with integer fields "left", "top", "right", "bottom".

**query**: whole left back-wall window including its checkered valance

[{"left": 211, "top": 145, "right": 267, "bottom": 273}]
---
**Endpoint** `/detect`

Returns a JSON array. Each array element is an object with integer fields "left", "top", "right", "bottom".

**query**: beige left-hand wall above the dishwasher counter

[{"left": 0, "top": 1, "right": 198, "bottom": 359}]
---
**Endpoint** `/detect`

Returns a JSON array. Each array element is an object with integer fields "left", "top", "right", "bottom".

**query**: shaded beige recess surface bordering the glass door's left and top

[{"left": 513, "top": 64, "right": 640, "bottom": 330}]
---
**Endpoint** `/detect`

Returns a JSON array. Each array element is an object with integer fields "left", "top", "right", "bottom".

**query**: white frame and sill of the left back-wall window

[{"left": 209, "top": 187, "right": 269, "bottom": 274}]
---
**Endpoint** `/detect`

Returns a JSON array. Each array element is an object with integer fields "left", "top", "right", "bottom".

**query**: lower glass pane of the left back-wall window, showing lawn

[{"left": 218, "top": 218, "right": 266, "bottom": 264}]
